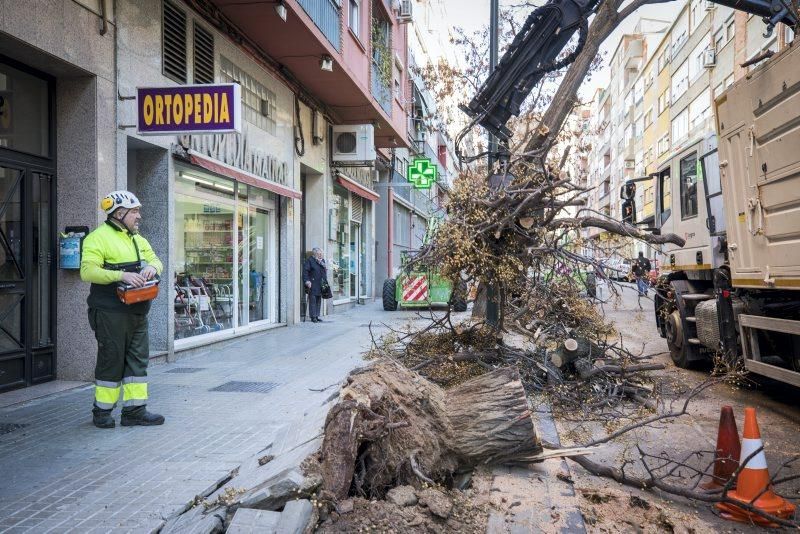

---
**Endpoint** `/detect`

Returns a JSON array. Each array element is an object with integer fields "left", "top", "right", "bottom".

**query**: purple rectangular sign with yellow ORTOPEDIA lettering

[{"left": 136, "top": 83, "right": 242, "bottom": 135}]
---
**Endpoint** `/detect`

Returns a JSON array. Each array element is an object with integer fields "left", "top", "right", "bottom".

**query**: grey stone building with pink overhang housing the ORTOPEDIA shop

[{"left": 0, "top": 0, "right": 418, "bottom": 392}]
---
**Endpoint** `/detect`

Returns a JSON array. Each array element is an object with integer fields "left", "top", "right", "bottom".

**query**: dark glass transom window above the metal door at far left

[{"left": 0, "top": 63, "right": 50, "bottom": 157}]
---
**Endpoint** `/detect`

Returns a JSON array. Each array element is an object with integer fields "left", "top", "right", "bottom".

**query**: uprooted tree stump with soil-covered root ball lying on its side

[{"left": 320, "top": 360, "right": 542, "bottom": 501}]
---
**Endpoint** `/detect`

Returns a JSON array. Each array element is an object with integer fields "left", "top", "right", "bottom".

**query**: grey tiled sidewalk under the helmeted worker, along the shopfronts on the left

[{"left": 0, "top": 303, "right": 404, "bottom": 534}]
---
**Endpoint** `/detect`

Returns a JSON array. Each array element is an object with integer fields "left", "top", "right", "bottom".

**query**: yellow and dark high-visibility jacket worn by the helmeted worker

[{"left": 81, "top": 221, "right": 164, "bottom": 314}]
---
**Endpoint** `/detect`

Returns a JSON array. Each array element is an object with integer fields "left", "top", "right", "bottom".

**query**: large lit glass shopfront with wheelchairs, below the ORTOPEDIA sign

[{"left": 175, "top": 167, "right": 278, "bottom": 339}]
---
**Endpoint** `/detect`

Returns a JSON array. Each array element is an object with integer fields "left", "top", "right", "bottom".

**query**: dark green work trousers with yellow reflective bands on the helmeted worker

[{"left": 89, "top": 308, "right": 150, "bottom": 416}]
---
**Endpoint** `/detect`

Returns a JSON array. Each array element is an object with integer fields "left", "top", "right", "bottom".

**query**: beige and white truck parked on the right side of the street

[{"left": 624, "top": 41, "right": 800, "bottom": 386}]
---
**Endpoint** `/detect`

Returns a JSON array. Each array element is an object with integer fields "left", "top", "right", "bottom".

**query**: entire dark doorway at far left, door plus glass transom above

[{"left": 0, "top": 55, "right": 57, "bottom": 392}]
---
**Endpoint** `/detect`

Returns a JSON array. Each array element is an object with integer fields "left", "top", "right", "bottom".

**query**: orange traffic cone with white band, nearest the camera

[{"left": 717, "top": 408, "right": 796, "bottom": 526}]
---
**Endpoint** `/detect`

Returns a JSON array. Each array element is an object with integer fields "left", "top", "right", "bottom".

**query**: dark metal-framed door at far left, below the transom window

[{"left": 0, "top": 161, "right": 55, "bottom": 391}]
